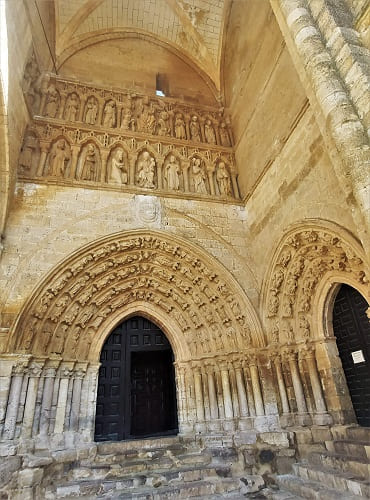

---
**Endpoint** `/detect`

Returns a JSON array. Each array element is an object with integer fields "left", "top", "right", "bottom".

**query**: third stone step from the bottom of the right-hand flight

[{"left": 308, "top": 451, "right": 370, "bottom": 480}]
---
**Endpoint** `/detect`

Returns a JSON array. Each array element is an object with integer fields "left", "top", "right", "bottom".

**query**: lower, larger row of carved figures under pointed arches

[{"left": 19, "top": 126, "right": 239, "bottom": 198}]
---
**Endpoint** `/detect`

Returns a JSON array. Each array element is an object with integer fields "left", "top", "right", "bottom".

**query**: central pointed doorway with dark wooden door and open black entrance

[{"left": 95, "top": 316, "right": 178, "bottom": 441}]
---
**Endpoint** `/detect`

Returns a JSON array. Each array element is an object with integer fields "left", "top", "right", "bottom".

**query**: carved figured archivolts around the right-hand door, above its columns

[{"left": 263, "top": 224, "right": 369, "bottom": 344}]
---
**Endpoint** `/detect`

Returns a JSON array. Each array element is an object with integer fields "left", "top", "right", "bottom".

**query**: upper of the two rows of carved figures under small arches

[{"left": 39, "top": 77, "right": 232, "bottom": 147}]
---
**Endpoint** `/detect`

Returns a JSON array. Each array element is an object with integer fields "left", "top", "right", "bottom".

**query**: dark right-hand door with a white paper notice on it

[{"left": 333, "top": 285, "right": 370, "bottom": 427}]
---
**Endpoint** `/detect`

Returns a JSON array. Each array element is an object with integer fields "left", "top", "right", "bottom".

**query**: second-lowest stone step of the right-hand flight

[{"left": 293, "top": 464, "right": 370, "bottom": 498}]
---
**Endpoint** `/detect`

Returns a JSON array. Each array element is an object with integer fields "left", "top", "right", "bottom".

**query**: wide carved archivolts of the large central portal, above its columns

[{"left": 9, "top": 231, "right": 264, "bottom": 360}]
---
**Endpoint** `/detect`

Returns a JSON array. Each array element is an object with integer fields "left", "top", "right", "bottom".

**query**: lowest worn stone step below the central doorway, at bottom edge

[{"left": 49, "top": 478, "right": 243, "bottom": 500}]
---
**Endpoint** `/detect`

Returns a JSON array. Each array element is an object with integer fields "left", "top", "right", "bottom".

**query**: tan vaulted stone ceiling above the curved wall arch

[{"left": 55, "top": 0, "right": 231, "bottom": 90}]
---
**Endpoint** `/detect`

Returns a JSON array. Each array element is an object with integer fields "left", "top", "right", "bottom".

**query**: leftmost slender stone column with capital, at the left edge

[{"left": 3, "top": 358, "right": 28, "bottom": 440}]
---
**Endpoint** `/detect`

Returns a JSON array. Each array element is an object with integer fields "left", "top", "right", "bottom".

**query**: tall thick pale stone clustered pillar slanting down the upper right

[{"left": 270, "top": 0, "right": 370, "bottom": 248}]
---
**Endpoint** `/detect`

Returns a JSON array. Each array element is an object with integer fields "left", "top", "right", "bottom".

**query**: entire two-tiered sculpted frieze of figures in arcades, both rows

[{"left": 19, "top": 73, "right": 239, "bottom": 201}]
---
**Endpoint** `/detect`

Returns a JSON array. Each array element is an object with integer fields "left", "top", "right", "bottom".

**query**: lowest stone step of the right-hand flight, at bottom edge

[{"left": 276, "top": 474, "right": 364, "bottom": 500}]
